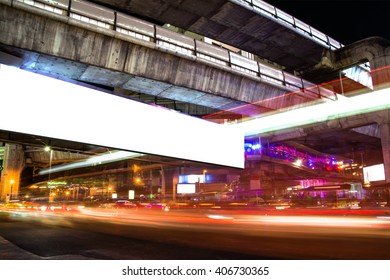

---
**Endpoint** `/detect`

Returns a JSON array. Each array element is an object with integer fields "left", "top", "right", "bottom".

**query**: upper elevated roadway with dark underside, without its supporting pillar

[{"left": 93, "top": 0, "right": 342, "bottom": 71}]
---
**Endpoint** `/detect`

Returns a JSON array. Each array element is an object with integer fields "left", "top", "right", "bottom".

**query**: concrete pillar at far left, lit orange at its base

[{"left": 0, "top": 144, "right": 25, "bottom": 201}]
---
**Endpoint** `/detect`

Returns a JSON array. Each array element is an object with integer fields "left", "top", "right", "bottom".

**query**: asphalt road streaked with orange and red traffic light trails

[{"left": 0, "top": 209, "right": 390, "bottom": 260}]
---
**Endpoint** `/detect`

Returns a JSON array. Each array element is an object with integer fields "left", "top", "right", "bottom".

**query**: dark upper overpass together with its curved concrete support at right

[{"left": 87, "top": 0, "right": 389, "bottom": 83}]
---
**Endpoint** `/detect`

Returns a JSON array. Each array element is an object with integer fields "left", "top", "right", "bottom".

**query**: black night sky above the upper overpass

[{"left": 265, "top": 0, "right": 390, "bottom": 45}]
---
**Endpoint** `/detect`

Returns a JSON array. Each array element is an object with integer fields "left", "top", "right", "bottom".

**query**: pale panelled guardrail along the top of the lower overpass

[{"left": 8, "top": 0, "right": 337, "bottom": 100}]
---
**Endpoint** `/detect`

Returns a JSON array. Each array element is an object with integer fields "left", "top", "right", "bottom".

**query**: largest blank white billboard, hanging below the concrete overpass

[{"left": 0, "top": 65, "right": 244, "bottom": 168}]
